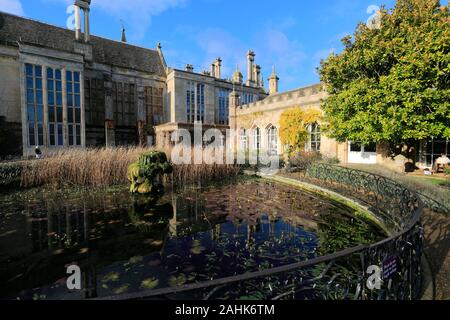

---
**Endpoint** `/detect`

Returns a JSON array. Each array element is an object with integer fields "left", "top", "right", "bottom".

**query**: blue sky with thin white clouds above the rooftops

[{"left": 0, "top": 0, "right": 448, "bottom": 91}]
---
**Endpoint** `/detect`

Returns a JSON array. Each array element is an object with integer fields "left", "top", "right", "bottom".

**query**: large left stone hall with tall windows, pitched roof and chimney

[{"left": 0, "top": 1, "right": 166, "bottom": 156}]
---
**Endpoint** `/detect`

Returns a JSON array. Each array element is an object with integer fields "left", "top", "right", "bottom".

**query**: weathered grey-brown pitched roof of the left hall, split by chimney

[{"left": 0, "top": 12, "right": 165, "bottom": 76}]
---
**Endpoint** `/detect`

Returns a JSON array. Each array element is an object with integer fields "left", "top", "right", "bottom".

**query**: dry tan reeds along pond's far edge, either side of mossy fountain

[{"left": 21, "top": 147, "right": 240, "bottom": 188}]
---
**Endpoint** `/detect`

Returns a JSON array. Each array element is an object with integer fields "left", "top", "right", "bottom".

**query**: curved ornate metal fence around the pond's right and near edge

[{"left": 99, "top": 164, "right": 423, "bottom": 300}]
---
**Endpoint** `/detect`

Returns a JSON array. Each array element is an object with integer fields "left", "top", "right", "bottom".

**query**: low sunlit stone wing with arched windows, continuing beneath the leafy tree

[{"left": 230, "top": 70, "right": 450, "bottom": 171}]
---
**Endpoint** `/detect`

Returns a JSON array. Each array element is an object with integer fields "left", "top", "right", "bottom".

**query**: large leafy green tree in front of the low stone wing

[{"left": 319, "top": 0, "right": 450, "bottom": 150}]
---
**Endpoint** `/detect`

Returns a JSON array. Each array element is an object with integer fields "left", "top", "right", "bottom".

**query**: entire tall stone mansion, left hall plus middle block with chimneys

[{"left": 0, "top": 0, "right": 267, "bottom": 157}]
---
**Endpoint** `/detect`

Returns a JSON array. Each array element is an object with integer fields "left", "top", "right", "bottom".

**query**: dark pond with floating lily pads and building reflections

[{"left": 0, "top": 179, "right": 384, "bottom": 299}]
